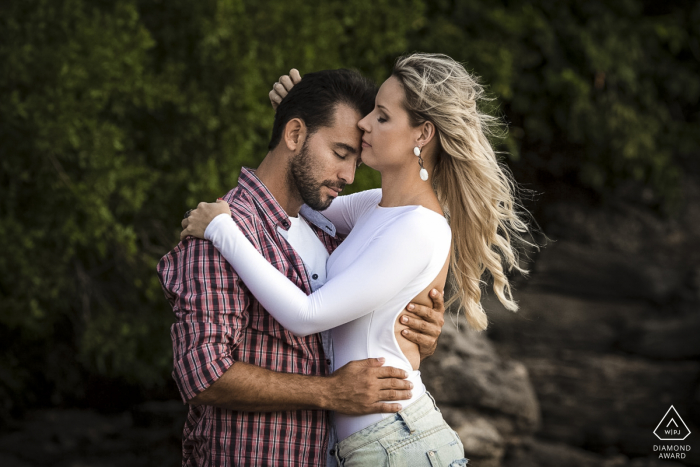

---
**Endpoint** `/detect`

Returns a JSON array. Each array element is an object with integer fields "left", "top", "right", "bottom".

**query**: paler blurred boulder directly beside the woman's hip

[{"left": 421, "top": 316, "right": 540, "bottom": 467}]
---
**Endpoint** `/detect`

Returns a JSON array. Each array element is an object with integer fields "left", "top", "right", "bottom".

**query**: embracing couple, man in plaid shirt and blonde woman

[{"left": 158, "top": 54, "right": 528, "bottom": 467}]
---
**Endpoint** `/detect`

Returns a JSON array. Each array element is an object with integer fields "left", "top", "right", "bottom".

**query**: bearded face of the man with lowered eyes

[{"left": 289, "top": 104, "right": 362, "bottom": 211}]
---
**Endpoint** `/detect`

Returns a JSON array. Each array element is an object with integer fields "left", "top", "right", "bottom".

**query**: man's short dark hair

[{"left": 268, "top": 69, "right": 377, "bottom": 150}]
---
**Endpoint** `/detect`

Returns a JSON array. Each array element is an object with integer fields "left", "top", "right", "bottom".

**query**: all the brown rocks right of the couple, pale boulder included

[{"left": 423, "top": 175, "right": 700, "bottom": 467}]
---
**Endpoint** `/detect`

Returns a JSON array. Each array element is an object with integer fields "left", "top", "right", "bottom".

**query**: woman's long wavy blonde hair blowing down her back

[{"left": 392, "top": 53, "right": 528, "bottom": 330}]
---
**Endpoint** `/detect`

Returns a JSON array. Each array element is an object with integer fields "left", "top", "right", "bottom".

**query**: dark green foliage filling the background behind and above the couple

[{"left": 0, "top": 0, "right": 700, "bottom": 415}]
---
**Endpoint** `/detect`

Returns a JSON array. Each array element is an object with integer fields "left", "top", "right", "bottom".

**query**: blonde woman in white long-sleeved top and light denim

[{"left": 183, "top": 54, "right": 527, "bottom": 466}]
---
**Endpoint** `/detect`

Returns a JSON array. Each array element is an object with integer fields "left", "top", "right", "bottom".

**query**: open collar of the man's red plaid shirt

[{"left": 238, "top": 167, "right": 336, "bottom": 237}]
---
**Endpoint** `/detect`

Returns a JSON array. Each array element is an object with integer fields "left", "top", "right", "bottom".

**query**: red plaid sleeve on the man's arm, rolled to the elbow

[{"left": 157, "top": 238, "right": 250, "bottom": 402}]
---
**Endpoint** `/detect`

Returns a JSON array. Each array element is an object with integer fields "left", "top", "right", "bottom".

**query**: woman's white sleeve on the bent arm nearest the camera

[{"left": 205, "top": 210, "right": 442, "bottom": 336}]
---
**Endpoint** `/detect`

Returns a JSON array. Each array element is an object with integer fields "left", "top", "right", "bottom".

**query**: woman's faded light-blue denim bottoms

[{"left": 335, "top": 393, "right": 469, "bottom": 467}]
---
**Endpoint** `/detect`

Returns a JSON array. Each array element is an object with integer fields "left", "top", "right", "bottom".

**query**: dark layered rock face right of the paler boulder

[{"left": 485, "top": 186, "right": 700, "bottom": 466}]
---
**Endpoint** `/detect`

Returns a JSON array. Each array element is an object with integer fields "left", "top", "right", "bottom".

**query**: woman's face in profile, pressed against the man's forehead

[{"left": 357, "top": 76, "right": 420, "bottom": 171}]
